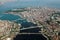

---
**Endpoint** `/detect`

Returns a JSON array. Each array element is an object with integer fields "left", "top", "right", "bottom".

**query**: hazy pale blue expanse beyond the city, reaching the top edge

[{"left": 0, "top": 0, "right": 60, "bottom": 12}]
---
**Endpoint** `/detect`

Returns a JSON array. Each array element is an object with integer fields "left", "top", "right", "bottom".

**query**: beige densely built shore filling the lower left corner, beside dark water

[{"left": 0, "top": 20, "right": 21, "bottom": 40}]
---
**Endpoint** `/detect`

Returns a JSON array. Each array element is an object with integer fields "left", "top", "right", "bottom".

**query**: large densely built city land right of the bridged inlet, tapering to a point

[{"left": 5, "top": 8, "right": 60, "bottom": 40}]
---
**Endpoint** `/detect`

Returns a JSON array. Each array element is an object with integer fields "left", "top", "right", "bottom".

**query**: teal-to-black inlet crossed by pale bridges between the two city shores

[{"left": 0, "top": 13, "right": 46, "bottom": 40}]
